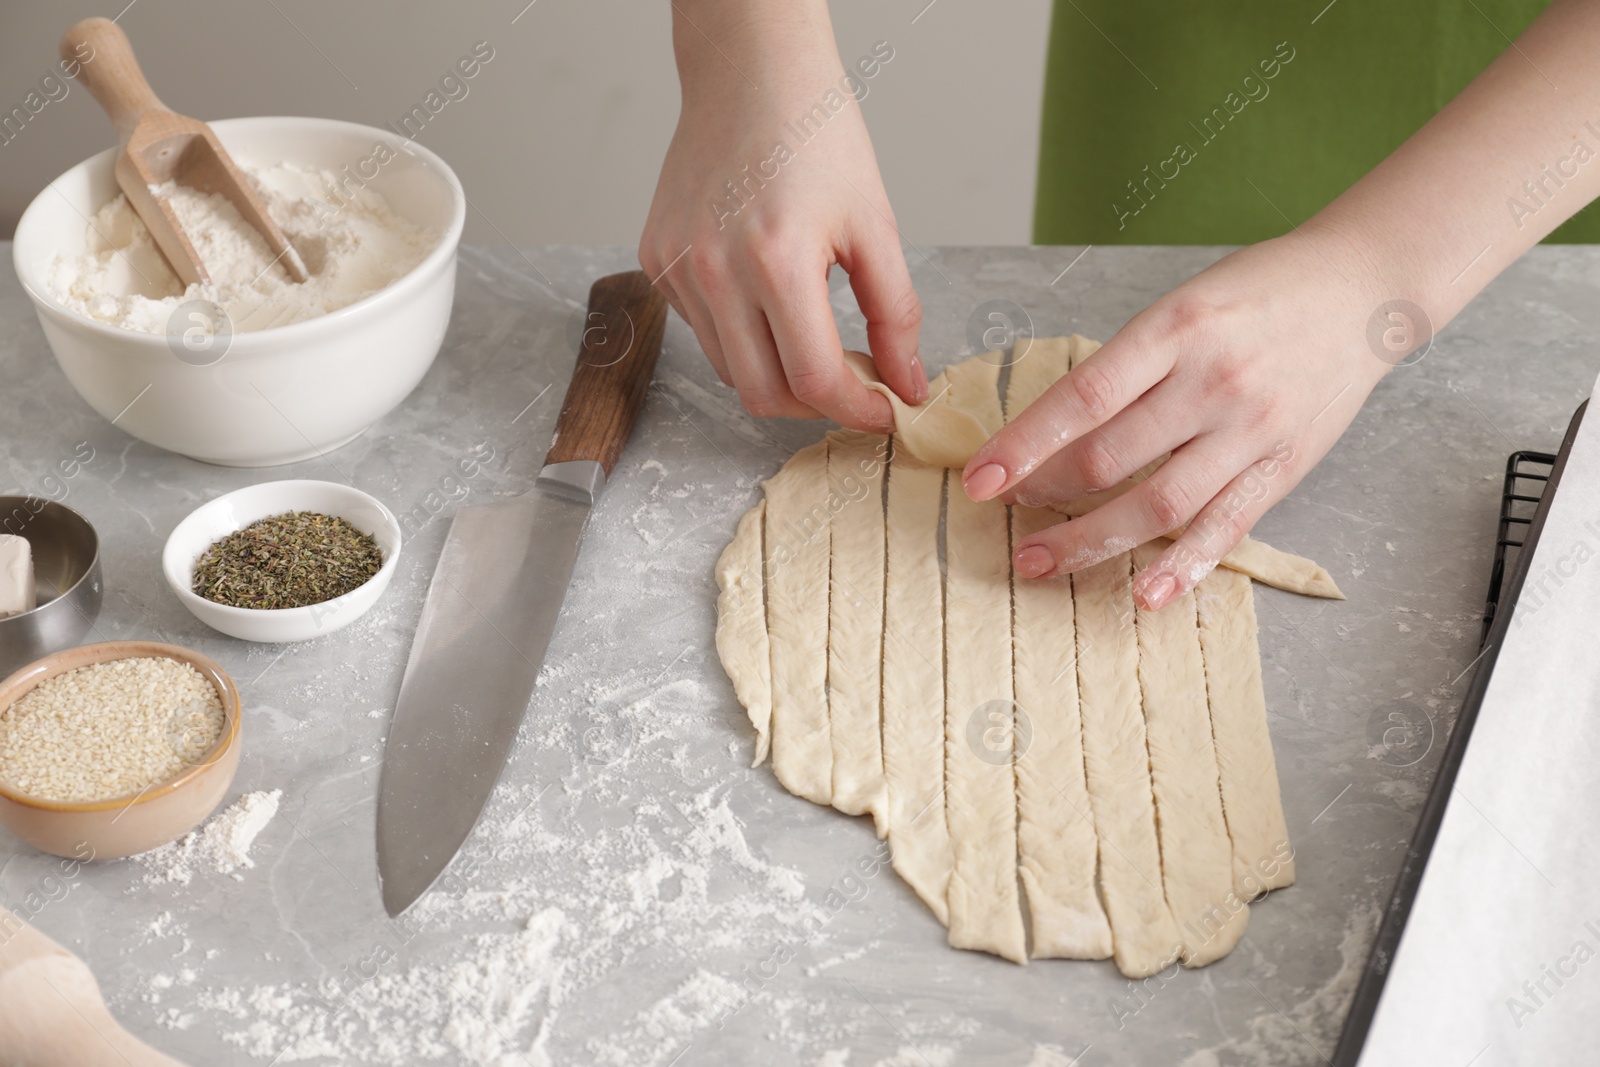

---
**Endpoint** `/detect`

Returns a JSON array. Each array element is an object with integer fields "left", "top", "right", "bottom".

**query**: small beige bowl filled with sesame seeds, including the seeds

[{"left": 0, "top": 641, "right": 240, "bottom": 861}]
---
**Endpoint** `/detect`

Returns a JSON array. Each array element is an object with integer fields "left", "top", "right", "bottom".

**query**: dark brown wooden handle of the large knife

[{"left": 544, "top": 270, "right": 667, "bottom": 477}]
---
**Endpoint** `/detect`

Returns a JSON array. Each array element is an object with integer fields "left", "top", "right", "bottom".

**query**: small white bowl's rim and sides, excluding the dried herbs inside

[{"left": 162, "top": 482, "right": 400, "bottom": 643}]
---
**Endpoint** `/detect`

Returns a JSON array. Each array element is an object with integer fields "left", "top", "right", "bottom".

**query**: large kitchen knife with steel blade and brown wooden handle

[{"left": 378, "top": 270, "right": 667, "bottom": 915}]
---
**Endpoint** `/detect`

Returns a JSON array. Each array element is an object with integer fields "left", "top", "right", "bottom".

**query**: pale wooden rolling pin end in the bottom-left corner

[{"left": 0, "top": 907, "right": 184, "bottom": 1067}]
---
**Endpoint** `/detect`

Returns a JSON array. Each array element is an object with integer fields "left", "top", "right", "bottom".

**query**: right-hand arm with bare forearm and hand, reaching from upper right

[{"left": 965, "top": 0, "right": 1600, "bottom": 608}]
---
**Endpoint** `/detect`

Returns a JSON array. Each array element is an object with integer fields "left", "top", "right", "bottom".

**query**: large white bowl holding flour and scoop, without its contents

[{"left": 13, "top": 118, "right": 466, "bottom": 467}]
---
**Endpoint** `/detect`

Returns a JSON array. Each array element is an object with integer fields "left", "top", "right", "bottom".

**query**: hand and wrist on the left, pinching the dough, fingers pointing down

[{"left": 638, "top": 0, "right": 928, "bottom": 432}]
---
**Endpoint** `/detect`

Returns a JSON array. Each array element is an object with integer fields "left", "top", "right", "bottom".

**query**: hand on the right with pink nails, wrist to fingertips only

[{"left": 963, "top": 229, "right": 1395, "bottom": 609}]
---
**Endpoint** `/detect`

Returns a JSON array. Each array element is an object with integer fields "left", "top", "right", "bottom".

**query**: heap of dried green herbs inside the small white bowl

[{"left": 194, "top": 512, "right": 384, "bottom": 609}]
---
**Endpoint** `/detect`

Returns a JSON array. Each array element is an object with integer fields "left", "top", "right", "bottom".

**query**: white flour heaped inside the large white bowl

[{"left": 43, "top": 163, "right": 442, "bottom": 333}]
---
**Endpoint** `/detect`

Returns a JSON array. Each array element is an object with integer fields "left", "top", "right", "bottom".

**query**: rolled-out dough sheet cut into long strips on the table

[{"left": 717, "top": 348, "right": 1331, "bottom": 977}]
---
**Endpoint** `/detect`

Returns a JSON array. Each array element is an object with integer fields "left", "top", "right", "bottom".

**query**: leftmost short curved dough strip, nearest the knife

[{"left": 717, "top": 501, "right": 773, "bottom": 766}]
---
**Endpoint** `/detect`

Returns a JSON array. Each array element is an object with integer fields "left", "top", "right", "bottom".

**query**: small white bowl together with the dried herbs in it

[{"left": 162, "top": 480, "right": 402, "bottom": 643}]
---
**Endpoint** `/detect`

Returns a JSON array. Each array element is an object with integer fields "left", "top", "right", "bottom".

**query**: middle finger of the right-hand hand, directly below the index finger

[{"left": 1003, "top": 379, "right": 1202, "bottom": 507}]
